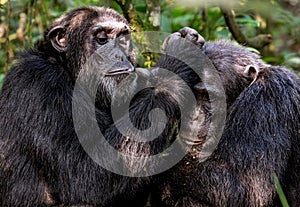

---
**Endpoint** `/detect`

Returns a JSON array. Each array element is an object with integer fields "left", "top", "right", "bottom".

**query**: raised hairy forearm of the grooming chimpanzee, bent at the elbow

[{"left": 101, "top": 32, "right": 203, "bottom": 176}]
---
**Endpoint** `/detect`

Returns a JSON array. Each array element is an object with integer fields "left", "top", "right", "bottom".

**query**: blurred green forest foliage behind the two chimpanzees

[{"left": 0, "top": 0, "right": 300, "bottom": 86}]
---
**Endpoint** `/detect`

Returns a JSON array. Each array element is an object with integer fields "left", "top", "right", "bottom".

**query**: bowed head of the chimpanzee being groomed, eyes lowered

[{"left": 180, "top": 40, "right": 268, "bottom": 154}]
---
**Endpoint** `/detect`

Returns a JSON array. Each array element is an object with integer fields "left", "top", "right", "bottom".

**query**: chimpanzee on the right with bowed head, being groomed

[{"left": 154, "top": 40, "right": 300, "bottom": 207}]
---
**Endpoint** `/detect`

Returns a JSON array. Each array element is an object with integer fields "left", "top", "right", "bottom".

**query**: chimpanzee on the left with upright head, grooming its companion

[{"left": 0, "top": 7, "right": 206, "bottom": 206}]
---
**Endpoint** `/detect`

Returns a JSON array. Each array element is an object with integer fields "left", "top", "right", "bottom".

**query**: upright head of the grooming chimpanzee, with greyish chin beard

[{"left": 39, "top": 7, "right": 135, "bottom": 106}]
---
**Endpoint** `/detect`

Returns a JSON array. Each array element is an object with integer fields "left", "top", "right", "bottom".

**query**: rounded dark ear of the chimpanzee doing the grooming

[{"left": 48, "top": 26, "right": 67, "bottom": 52}]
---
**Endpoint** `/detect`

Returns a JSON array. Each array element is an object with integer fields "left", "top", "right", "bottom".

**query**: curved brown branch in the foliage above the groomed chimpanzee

[{"left": 221, "top": 8, "right": 272, "bottom": 49}]
